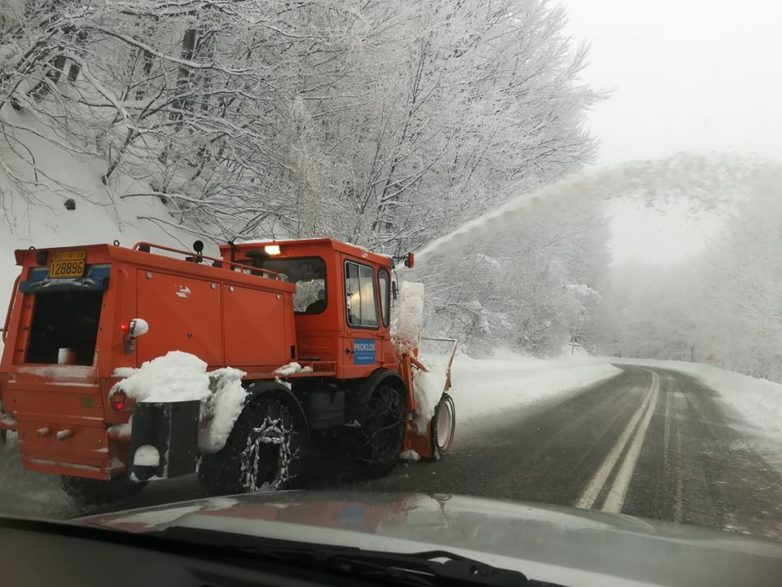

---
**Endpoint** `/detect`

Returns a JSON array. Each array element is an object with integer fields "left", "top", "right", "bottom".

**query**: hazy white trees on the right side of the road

[{"left": 591, "top": 161, "right": 782, "bottom": 381}]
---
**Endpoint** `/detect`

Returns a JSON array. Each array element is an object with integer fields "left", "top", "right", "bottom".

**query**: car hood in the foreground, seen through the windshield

[{"left": 74, "top": 491, "right": 782, "bottom": 585}]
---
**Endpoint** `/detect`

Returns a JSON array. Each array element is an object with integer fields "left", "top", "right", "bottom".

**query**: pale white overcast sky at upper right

[{"left": 562, "top": 0, "right": 782, "bottom": 164}]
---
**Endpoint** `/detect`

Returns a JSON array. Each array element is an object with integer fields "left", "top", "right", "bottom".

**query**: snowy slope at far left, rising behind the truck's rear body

[{"left": 0, "top": 108, "right": 194, "bottom": 340}]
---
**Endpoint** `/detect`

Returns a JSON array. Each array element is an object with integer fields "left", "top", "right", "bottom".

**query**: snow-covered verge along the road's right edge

[{"left": 606, "top": 357, "right": 782, "bottom": 470}]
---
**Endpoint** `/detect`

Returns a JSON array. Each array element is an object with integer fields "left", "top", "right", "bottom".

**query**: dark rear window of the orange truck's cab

[{"left": 249, "top": 255, "right": 327, "bottom": 314}]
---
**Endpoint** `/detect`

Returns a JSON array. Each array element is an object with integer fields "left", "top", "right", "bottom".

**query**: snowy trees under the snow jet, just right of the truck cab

[{"left": 411, "top": 195, "right": 608, "bottom": 356}]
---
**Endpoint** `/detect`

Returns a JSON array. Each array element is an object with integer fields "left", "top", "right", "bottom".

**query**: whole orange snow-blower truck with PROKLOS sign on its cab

[{"left": 0, "top": 239, "right": 456, "bottom": 503}]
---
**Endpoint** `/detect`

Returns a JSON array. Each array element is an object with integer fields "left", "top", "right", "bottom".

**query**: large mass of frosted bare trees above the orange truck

[{"left": 0, "top": 0, "right": 597, "bottom": 253}]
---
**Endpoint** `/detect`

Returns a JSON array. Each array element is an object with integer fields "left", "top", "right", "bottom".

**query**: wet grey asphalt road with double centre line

[{"left": 0, "top": 365, "right": 782, "bottom": 541}]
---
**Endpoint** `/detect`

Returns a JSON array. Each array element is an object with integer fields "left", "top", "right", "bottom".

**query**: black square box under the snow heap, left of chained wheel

[{"left": 129, "top": 401, "right": 201, "bottom": 481}]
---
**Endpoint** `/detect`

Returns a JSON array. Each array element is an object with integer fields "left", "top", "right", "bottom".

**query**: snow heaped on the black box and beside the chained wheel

[{"left": 111, "top": 351, "right": 247, "bottom": 452}]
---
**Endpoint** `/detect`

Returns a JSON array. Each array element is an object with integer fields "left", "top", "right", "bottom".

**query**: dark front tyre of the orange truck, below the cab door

[{"left": 356, "top": 383, "right": 405, "bottom": 477}]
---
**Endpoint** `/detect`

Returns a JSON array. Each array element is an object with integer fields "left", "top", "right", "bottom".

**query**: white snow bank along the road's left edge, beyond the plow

[{"left": 440, "top": 353, "right": 621, "bottom": 426}]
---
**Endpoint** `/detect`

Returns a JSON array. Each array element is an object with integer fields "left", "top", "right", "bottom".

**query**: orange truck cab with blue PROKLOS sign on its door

[{"left": 225, "top": 239, "right": 397, "bottom": 379}]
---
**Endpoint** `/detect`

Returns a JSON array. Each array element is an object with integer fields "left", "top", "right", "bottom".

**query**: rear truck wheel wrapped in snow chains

[{"left": 198, "top": 396, "right": 303, "bottom": 495}]
